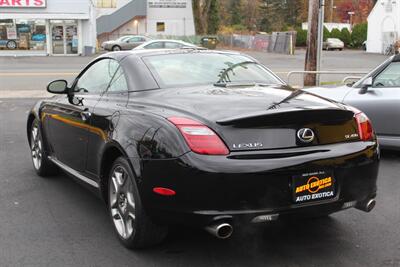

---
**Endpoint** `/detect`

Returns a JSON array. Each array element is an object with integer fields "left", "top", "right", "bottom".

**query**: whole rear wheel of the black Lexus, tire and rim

[{"left": 107, "top": 157, "right": 168, "bottom": 249}]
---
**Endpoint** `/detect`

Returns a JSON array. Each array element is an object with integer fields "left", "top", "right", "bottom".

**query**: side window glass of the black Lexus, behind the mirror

[{"left": 74, "top": 59, "right": 118, "bottom": 94}]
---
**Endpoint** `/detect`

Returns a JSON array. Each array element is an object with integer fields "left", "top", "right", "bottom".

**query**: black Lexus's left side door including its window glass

[{"left": 48, "top": 58, "right": 115, "bottom": 172}]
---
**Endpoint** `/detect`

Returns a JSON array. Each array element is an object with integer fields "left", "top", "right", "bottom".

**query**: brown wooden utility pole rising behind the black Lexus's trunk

[{"left": 304, "top": 0, "right": 320, "bottom": 86}]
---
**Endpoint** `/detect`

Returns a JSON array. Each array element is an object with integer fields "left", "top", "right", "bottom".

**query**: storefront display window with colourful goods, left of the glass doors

[{"left": 0, "top": 19, "right": 47, "bottom": 51}]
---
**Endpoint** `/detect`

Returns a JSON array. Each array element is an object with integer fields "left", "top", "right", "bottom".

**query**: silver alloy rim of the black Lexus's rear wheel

[{"left": 109, "top": 165, "right": 136, "bottom": 239}]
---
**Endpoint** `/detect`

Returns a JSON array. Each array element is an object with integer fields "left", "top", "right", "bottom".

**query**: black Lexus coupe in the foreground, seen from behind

[{"left": 27, "top": 49, "right": 379, "bottom": 248}]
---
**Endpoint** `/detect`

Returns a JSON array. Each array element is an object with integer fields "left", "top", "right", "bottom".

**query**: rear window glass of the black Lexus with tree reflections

[{"left": 143, "top": 53, "right": 283, "bottom": 87}]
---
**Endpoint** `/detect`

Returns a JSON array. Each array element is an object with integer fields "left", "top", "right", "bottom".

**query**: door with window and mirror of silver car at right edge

[{"left": 344, "top": 62, "right": 400, "bottom": 136}]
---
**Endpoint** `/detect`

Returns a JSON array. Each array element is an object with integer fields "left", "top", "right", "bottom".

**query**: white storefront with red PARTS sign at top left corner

[{"left": 0, "top": 0, "right": 96, "bottom": 56}]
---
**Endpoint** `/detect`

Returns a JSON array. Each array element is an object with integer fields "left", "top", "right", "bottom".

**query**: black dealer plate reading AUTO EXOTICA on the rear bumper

[{"left": 292, "top": 171, "right": 336, "bottom": 203}]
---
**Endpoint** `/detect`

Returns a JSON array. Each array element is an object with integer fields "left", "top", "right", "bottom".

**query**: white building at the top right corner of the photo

[{"left": 367, "top": 0, "right": 400, "bottom": 53}]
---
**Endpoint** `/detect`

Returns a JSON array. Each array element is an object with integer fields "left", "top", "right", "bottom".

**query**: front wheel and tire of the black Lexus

[{"left": 29, "top": 119, "right": 58, "bottom": 177}]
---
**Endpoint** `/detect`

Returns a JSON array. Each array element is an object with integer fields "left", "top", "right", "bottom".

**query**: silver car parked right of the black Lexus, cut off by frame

[{"left": 305, "top": 55, "right": 400, "bottom": 150}]
